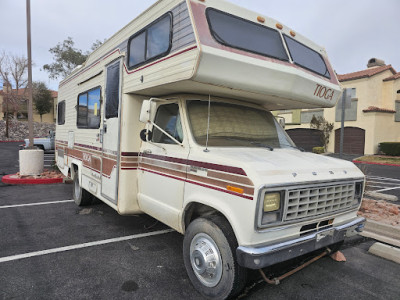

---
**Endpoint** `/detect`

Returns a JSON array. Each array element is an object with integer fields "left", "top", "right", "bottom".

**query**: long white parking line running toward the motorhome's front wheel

[{"left": 0, "top": 229, "right": 175, "bottom": 263}]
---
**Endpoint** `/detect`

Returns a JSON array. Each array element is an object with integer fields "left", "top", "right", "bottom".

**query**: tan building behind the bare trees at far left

[{"left": 0, "top": 86, "right": 58, "bottom": 123}]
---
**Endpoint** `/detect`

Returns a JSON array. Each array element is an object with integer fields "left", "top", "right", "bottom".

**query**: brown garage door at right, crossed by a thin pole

[{"left": 335, "top": 127, "right": 365, "bottom": 154}]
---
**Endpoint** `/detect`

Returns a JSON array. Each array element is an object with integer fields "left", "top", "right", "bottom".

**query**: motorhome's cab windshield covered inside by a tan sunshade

[{"left": 187, "top": 100, "right": 295, "bottom": 150}]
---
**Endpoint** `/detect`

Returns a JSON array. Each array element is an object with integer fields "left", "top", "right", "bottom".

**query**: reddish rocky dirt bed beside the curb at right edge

[{"left": 358, "top": 198, "right": 400, "bottom": 227}]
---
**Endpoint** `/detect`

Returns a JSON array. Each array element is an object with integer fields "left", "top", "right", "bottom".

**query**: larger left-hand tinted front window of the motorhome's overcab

[{"left": 207, "top": 9, "right": 289, "bottom": 60}]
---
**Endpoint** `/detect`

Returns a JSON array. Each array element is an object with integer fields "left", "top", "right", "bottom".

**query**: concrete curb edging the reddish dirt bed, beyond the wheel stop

[{"left": 361, "top": 220, "right": 400, "bottom": 247}]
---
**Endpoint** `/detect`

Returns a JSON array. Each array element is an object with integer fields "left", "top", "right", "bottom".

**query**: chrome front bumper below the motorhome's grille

[{"left": 236, "top": 218, "right": 365, "bottom": 269}]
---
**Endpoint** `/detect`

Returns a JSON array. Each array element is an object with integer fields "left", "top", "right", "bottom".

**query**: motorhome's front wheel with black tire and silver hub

[{"left": 183, "top": 216, "right": 247, "bottom": 299}]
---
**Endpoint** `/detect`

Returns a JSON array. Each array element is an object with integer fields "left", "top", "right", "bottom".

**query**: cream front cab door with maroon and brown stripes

[{"left": 138, "top": 103, "right": 189, "bottom": 229}]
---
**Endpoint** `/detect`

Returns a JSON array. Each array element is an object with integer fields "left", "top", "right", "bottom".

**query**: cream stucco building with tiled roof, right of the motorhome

[{"left": 275, "top": 58, "right": 400, "bottom": 154}]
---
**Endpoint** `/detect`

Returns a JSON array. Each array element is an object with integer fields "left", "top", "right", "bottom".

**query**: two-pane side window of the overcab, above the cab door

[{"left": 128, "top": 13, "right": 172, "bottom": 69}]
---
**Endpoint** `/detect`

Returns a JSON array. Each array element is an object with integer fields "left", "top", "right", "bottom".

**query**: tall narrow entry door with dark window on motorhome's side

[{"left": 101, "top": 60, "right": 121, "bottom": 204}]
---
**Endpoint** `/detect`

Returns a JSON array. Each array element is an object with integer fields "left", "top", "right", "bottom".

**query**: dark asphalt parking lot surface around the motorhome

[{"left": 0, "top": 144, "right": 400, "bottom": 299}]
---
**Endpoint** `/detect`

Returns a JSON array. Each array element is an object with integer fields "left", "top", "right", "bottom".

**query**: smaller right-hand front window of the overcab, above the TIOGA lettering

[{"left": 284, "top": 35, "right": 330, "bottom": 78}]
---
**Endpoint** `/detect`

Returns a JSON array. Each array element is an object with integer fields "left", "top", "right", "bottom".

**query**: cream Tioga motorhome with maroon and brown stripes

[{"left": 56, "top": 0, "right": 364, "bottom": 299}]
